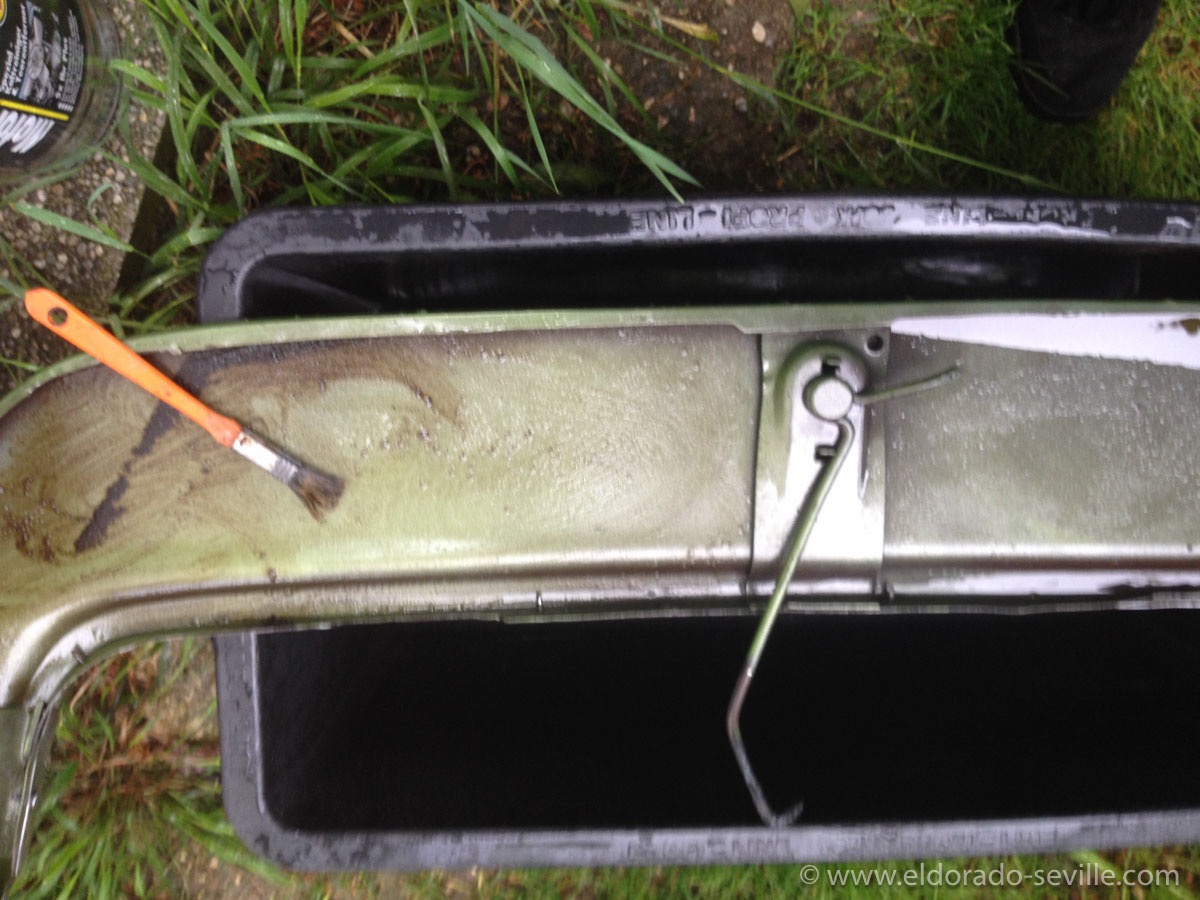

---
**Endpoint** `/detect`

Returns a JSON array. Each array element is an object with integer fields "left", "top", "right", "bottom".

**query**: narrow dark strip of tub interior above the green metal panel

[{"left": 225, "top": 239, "right": 1200, "bottom": 320}]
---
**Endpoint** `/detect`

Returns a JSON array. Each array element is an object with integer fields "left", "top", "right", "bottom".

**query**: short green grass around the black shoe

[{"left": 779, "top": 0, "right": 1200, "bottom": 199}]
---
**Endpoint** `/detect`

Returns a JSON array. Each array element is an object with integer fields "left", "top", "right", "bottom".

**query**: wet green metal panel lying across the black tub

[{"left": 0, "top": 305, "right": 1200, "bottom": 744}]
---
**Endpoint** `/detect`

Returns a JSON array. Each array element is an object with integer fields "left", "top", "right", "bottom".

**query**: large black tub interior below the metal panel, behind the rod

[{"left": 257, "top": 611, "right": 1200, "bottom": 830}]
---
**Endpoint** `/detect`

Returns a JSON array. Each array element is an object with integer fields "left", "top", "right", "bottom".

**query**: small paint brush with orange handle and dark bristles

[{"left": 25, "top": 288, "right": 344, "bottom": 521}]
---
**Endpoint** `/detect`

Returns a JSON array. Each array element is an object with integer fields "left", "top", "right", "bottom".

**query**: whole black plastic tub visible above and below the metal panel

[{"left": 206, "top": 197, "right": 1200, "bottom": 869}]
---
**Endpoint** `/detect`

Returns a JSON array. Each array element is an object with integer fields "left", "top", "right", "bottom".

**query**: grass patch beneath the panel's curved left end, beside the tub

[{"left": 14, "top": 642, "right": 281, "bottom": 898}]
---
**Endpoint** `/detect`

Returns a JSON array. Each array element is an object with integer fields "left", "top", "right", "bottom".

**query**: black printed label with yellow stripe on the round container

[{"left": 0, "top": 0, "right": 86, "bottom": 166}]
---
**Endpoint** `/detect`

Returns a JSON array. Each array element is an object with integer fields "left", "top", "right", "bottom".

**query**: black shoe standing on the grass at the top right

[{"left": 1008, "top": 0, "right": 1159, "bottom": 122}]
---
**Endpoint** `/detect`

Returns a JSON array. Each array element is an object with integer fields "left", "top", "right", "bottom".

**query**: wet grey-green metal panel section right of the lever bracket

[{"left": 883, "top": 336, "right": 1200, "bottom": 594}]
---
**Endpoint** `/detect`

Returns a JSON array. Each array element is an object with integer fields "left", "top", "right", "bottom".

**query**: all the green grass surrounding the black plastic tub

[{"left": 7, "top": 0, "right": 1200, "bottom": 898}]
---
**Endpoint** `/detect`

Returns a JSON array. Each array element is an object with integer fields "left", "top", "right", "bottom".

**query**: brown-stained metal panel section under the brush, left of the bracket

[{"left": 0, "top": 328, "right": 758, "bottom": 703}]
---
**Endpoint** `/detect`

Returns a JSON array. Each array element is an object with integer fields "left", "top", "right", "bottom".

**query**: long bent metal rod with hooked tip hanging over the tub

[{"left": 725, "top": 419, "right": 854, "bottom": 828}]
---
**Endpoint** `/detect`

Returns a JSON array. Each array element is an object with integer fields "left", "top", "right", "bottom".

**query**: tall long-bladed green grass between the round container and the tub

[{"left": 5, "top": 0, "right": 695, "bottom": 330}]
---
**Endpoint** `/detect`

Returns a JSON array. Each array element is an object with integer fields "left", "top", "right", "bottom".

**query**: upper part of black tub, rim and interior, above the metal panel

[{"left": 197, "top": 197, "right": 1200, "bottom": 323}]
